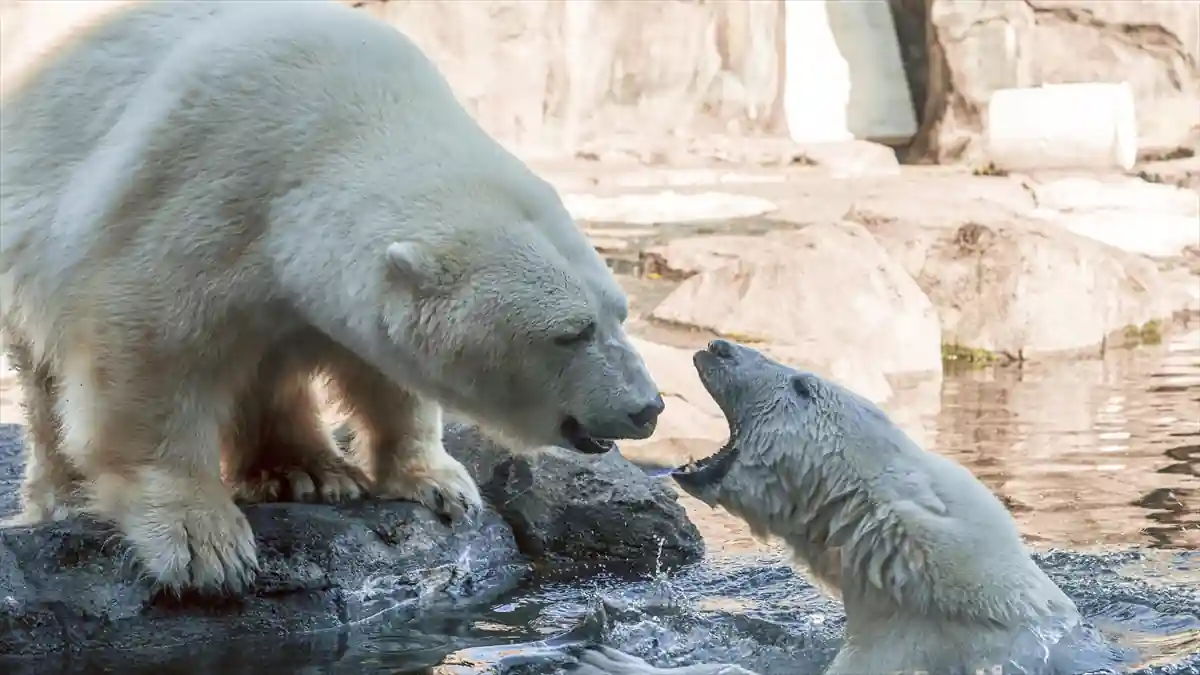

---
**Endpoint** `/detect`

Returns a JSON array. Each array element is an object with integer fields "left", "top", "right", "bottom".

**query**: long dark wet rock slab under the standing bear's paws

[{"left": 0, "top": 494, "right": 521, "bottom": 655}]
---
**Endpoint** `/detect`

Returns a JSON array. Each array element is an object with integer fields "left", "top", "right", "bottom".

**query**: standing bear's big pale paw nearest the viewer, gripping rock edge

[{"left": 120, "top": 487, "right": 258, "bottom": 596}]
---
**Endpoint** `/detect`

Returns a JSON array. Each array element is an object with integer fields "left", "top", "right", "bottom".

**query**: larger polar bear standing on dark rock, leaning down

[{"left": 0, "top": 0, "right": 662, "bottom": 591}]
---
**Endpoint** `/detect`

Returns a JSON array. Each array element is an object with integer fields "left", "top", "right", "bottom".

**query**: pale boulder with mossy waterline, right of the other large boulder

[{"left": 870, "top": 212, "right": 1172, "bottom": 358}]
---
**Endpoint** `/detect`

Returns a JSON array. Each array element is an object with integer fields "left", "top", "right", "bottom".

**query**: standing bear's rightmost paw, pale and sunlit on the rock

[{"left": 372, "top": 452, "right": 484, "bottom": 521}]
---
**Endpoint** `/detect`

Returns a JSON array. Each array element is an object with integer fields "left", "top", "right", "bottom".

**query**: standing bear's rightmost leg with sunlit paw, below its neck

[{"left": 331, "top": 354, "right": 482, "bottom": 520}]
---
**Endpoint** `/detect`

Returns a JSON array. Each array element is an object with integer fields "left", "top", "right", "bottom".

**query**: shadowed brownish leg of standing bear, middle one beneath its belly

[{"left": 222, "top": 363, "right": 368, "bottom": 503}]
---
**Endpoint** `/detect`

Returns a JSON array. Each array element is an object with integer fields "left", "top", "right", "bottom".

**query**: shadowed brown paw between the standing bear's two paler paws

[{"left": 233, "top": 452, "right": 370, "bottom": 504}]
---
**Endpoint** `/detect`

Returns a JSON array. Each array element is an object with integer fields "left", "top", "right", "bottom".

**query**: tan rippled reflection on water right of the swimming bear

[{"left": 936, "top": 331, "right": 1200, "bottom": 549}]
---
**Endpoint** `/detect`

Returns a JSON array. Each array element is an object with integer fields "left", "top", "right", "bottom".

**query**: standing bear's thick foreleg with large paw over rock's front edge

[{"left": 59, "top": 341, "right": 258, "bottom": 595}]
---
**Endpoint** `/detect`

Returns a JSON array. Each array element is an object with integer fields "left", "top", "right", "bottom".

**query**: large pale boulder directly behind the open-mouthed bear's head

[{"left": 652, "top": 222, "right": 942, "bottom": 400}]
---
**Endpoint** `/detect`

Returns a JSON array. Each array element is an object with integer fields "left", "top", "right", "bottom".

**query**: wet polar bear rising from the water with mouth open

[{"left": 572, "top": 340, "right": 1120, "bottom": 675}]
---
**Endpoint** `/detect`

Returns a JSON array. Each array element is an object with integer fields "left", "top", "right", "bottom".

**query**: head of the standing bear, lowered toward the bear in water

[{"left": 384, "top": 186, "right": 664, "bottom": 454}]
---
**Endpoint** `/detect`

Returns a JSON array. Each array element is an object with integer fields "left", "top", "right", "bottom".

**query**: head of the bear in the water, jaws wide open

[{"left": 672, "top": 340, "right": 893, "bottom": 516}]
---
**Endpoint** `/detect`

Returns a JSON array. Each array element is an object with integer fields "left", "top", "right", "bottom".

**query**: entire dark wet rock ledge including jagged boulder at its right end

[{"left": 0, "top": 425, "right": 702, "bottom": 658}]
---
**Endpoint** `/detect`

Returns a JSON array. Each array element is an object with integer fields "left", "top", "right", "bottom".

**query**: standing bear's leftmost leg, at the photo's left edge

[{"left": 5, "top": 327, "right": 83, "bottom": 526}]
